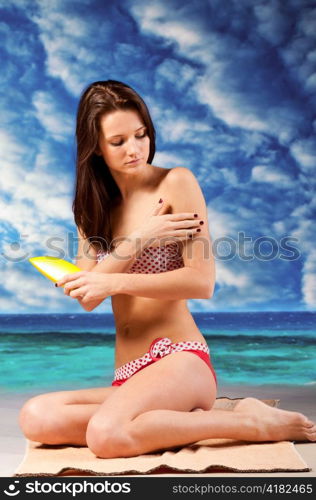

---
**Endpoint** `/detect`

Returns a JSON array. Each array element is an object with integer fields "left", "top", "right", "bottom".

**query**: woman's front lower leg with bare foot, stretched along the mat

[{"left": 125, "top": 398, "right": 316, "bottom": 455}]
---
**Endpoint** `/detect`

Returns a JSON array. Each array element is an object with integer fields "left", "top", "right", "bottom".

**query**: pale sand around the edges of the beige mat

[{"left": 0, "top": 385, "right": 316, "bottom": 477}]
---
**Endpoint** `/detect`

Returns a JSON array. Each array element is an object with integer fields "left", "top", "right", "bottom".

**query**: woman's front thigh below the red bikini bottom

[{"left": 94, "top": 351, "right": 216, "bottom": 422}]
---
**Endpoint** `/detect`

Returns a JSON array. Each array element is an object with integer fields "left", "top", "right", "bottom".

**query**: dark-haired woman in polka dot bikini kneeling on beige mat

[{"left": 20, "top": 80, "right": 316, "bottom": 458}]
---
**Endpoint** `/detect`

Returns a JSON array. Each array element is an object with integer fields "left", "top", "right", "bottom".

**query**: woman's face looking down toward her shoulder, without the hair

[{"left": 99, "top": 110, "right": 150, "bottom": 173}]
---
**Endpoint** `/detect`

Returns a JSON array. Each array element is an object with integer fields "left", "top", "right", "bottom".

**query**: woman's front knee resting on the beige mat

[{"left": 86, "top": 417, "right": 137, "bottom": 458}]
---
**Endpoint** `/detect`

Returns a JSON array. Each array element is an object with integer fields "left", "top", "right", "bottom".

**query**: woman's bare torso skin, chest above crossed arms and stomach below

[{"left": 111, "top": 167, "right": 205, "bottom": 368}]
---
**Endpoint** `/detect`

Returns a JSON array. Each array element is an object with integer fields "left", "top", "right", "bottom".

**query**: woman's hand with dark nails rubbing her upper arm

[{"left": 130, "top": 198, "right": 204, "bottom": 246}]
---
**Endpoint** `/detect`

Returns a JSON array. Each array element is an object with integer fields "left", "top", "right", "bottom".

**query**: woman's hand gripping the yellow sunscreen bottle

[{"left": 56, "top": 271, "right": 113, "bottom": 306}]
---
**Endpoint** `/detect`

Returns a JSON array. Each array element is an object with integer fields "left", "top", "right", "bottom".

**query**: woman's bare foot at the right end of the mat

[{"left": 234, "top": 398, "right": 316, "bottom": 442}]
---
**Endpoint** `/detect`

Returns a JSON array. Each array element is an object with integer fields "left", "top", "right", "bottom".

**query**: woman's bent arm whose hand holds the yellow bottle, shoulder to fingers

[{"left": 59, "top": 167, "right": 215, "bottom": 302}]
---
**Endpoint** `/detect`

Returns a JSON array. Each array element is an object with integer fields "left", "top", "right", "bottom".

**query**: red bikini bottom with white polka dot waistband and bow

[{"left": 112, "top": 337, "right": 217, "bottom": 386}]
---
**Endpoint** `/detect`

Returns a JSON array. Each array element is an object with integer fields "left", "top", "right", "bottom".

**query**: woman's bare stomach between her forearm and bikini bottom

[{"left": 112, "top": 295, "right": 206, "bottom": 368}]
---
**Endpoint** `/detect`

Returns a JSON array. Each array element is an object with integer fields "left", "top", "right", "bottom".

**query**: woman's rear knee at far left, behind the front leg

[{"left": 19, "top": 395, "right": 56, "bottom": 444}]
